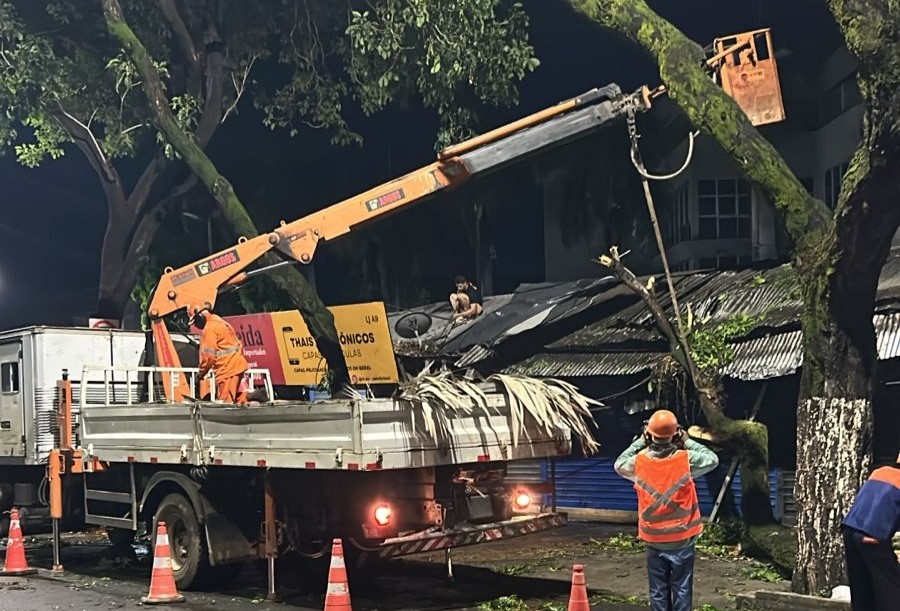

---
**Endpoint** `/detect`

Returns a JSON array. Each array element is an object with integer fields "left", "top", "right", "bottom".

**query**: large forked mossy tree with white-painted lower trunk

[{"left": 569, "top": 0, "right": 900, "bottom": 593}]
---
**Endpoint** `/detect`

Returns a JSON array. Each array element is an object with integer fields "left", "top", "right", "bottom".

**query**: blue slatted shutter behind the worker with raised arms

[{"left": 542, "top": 457, "right": 778, "bottom": 517}]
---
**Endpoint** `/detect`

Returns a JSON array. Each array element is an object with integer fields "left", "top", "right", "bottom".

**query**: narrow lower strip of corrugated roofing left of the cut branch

[{"left": 504, "top": 352, "right": 665, "bottom": 378}]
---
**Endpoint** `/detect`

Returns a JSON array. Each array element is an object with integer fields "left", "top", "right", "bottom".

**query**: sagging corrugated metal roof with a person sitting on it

[{"left": 389, "top": 251, "right": 900, "bottom": 380}]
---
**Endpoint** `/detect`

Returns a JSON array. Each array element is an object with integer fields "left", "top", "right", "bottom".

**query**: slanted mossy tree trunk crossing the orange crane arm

[{"left": 102, "top": 0, "right": 349, "bottom": 386}]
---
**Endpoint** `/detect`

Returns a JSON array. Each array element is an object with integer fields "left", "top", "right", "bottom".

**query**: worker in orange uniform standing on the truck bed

[{"left": 188, "top": 306, "right": 250, "bottom": 405}]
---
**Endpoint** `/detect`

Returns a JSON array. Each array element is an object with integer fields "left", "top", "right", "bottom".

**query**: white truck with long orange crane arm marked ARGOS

[{"left": 0, "top": 27, "right": 770, "bottom": 595}]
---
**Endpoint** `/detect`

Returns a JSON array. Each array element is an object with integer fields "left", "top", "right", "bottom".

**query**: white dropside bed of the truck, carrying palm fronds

[{"left": 78, "top": 394, "right": 571, "bottom": 471}]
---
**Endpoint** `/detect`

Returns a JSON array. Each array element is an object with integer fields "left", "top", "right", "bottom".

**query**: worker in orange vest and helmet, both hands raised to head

[{"left": 615, "top": 409, "right": 719, "bottom": 611}]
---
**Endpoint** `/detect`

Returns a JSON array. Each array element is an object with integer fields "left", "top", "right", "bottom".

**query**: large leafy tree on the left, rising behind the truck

[{"left": 0, "top": 0, "right": 537, "bottom": 388}]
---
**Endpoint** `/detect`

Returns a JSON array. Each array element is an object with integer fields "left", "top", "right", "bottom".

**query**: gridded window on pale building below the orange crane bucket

[{"left": 697, "top": 178, "right": 751, "bottom": 240}]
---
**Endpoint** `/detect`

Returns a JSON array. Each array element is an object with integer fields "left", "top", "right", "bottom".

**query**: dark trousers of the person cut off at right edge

[{"left": 844, "top": 527, "right": 900, "bottom": 611}]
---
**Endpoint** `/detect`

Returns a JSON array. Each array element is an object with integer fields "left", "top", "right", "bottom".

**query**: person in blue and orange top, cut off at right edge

[{"left": 843, "top": 455, "right": 900, "bottom": 611}]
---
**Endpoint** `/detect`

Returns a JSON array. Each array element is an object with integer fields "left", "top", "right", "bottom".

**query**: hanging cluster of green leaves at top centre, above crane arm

[{"left": 347, "top": 0, "right": 540, "bottom": 147}]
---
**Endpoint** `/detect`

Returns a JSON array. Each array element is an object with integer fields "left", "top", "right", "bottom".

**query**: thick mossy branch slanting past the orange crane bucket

[{"left": 569, "top": 0, "right": 832, "bottom": 252}]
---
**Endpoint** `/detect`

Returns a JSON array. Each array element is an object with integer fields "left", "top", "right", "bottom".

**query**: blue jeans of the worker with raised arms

[{"left": 647, "top": 545, "right": 694, "bottom": 611}]
